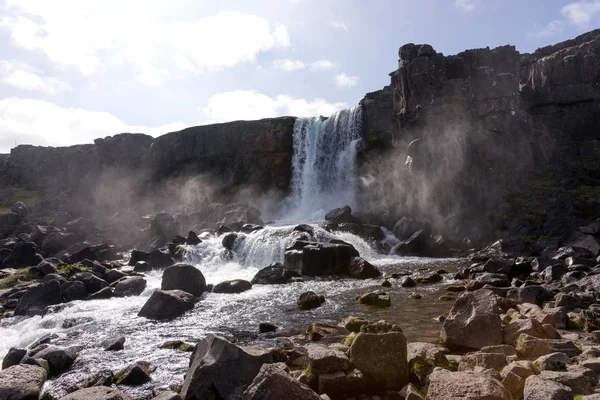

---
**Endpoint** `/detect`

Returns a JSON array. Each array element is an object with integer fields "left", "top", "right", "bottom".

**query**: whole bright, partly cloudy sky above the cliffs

[{"left": 0, "top": 0, "right": 600, "bottom": 153}]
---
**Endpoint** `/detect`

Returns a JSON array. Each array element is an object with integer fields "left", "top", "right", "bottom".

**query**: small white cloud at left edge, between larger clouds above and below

[{"left": 0, "top": 60, "right": 73, "bottom": 95}]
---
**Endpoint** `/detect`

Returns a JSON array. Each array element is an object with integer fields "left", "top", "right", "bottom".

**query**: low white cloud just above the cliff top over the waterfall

[{"left": 202, "top": 90, "right": 348, "bottom": 123}]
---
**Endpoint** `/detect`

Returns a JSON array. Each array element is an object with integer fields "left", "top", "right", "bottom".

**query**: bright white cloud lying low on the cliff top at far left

[{"left": 0, "top": 98, "right": 186, "bottom": 152}]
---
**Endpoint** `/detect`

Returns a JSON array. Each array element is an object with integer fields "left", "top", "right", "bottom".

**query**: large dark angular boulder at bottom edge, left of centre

[{"left": 181, "top": 334, "right": 273, "bottom": 400}]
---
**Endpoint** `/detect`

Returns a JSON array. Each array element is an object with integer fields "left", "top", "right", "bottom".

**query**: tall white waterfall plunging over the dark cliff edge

[{"left": 288, "top": 106, "right": 362, "bottom": 221}]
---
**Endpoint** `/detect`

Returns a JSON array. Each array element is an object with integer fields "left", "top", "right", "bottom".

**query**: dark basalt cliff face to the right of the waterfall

[{"left": 360, "top": 30, "right": 600, "bottom": 244}]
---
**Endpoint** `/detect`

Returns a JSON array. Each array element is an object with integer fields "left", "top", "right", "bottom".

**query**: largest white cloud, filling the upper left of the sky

[{"left": 0, "top": 0, "right": 290, "bottom": 85}]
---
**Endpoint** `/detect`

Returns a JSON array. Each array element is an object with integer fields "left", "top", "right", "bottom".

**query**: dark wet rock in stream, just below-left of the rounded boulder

[{"left": 138, "top": 290, "right": 194, "bottom": 319}]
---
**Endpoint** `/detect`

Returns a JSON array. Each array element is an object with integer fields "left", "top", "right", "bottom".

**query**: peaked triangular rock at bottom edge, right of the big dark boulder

[{"left": 240, "top": 364, "right": 323, "bottom": 400}]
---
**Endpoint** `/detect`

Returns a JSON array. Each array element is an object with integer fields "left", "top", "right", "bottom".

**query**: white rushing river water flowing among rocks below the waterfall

[{"left": 0, "top": 226, "right": 466, "bottom": 398}]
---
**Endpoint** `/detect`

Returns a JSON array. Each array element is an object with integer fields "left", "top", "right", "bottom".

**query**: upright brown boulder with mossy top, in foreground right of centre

[{"left": 348, "top": 322, "right": 408, "bottom": 389}]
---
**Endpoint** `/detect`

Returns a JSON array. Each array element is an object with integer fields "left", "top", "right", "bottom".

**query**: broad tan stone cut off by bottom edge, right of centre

[{"left": 427, "top": 368, "right": 512, "bottom": 400}]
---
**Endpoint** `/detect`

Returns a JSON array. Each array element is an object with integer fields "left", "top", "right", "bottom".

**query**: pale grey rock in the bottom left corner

[{"left": 0, "top": 365, "right": 47, "bottom": 400}]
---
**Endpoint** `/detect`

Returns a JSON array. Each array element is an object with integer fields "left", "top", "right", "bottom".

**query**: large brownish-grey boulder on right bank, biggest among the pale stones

[{"left": 440, "top": 289, "right": 502, "bottom": 350}]
